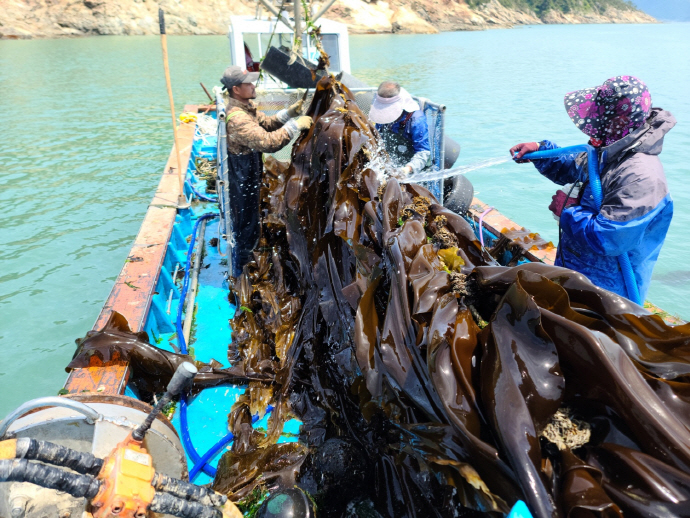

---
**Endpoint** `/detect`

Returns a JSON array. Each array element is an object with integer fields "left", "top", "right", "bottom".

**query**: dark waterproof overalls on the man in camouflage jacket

[{"left": 228, "top": 151, "right": 263, "bottom": 277}]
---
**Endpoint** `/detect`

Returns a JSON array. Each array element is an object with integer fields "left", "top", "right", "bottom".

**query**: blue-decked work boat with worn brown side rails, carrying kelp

[{"left": 0, "top": 2, "right": 680, "bottom": 518}]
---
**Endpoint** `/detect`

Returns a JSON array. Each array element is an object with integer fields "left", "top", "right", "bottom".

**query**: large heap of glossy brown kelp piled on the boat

[{"left": 214, "top": 78, "right": 690, "bottom": 518}]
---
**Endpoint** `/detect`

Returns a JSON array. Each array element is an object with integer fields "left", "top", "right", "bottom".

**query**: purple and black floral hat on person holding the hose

[{"left": 563, "top": 76, "right": 652, "bottom": 146}]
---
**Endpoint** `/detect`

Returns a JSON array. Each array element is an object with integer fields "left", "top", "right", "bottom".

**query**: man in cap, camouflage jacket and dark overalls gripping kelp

[{"left": 220, "top": 66, "right": 312, "bottom": 277}]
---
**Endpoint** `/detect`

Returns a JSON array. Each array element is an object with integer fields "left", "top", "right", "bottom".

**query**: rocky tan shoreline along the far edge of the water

[{"left": 0, "top": 0, "right": 656, "bottom": 39}]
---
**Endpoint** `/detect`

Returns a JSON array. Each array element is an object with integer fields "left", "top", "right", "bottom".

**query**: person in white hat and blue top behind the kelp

[{"left": 369, "top": 81, "right": 431, "bottom": 176}]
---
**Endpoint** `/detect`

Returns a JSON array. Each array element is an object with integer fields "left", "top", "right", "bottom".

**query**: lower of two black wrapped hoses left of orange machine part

[{"left": 0, "top": 459, "right": 101, "bottom": 500}]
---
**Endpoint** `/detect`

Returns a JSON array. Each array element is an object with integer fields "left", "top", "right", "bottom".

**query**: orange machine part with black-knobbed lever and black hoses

[{"left": 0, "top": 362, "right": 237, "bottom": 518}]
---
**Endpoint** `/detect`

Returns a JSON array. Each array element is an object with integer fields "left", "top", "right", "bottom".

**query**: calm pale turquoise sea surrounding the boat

[{"left": 0, "top": 24, "right": 690, "bottom": 418}]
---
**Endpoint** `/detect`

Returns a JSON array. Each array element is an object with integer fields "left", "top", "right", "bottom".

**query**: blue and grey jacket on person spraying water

[{"left": 534, "top": 108, "right": 676, "bottom": 300}]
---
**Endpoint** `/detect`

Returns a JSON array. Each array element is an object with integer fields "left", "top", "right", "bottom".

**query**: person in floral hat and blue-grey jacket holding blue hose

[{"left": 510, "top": 76, "right": 676, "bottom": 301}]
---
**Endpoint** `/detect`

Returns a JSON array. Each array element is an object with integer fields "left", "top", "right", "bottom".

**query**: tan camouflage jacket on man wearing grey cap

[{"left": 225, "top": 97, "right": 290, "bottom": 155}]
